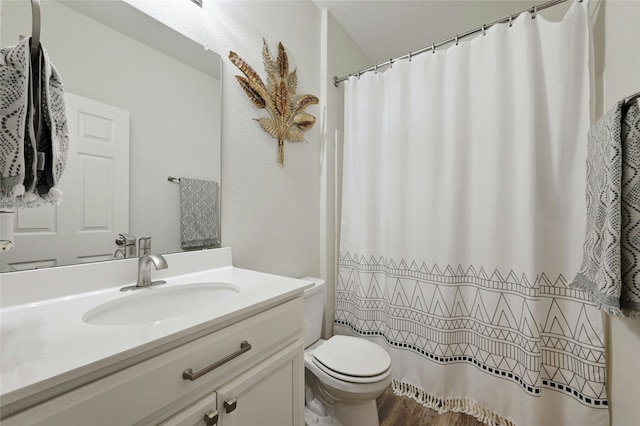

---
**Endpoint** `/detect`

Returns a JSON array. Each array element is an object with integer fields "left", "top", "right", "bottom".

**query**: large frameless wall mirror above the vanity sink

[{"left": 0, "top": 0, "right": 222, "bottom": 272}]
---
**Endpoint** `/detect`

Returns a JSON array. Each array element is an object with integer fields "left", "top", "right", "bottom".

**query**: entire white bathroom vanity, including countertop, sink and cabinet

[{"left": 0, "top": 249, "right": 312, "bottom": 426}]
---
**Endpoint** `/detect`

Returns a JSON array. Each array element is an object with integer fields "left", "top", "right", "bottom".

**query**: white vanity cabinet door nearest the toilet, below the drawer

[{"left": 217, "top": 340, "right": 304, "bottom": 426}]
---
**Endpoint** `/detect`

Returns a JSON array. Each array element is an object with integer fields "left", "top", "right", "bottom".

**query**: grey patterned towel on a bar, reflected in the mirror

[{"left": 180, "top": 178, "right": 220, "bottom": 249}]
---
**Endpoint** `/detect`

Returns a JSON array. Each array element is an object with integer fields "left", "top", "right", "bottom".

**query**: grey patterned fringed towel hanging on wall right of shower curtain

[{"left": 571, "top": 95, "right": 640, "bottom": 319}]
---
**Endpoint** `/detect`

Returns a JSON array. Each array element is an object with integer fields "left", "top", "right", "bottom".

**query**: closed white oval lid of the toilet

[{"left": 313, "top": 336, "right": 391, "bottom": 377}]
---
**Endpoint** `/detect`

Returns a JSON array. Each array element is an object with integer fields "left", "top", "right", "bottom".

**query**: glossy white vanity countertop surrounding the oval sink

[{"left": 0, "top": 249, "right": 311, "bottom": 414}]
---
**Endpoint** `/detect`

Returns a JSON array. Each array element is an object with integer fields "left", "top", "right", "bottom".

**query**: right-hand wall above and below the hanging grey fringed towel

[{"left": 595, "top": 0, "right": 640, "bottom": 426}]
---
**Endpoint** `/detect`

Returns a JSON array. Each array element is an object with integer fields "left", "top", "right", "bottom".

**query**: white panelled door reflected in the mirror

[{"left": 2, "top": 93, "right": 129, "bottom": 270}]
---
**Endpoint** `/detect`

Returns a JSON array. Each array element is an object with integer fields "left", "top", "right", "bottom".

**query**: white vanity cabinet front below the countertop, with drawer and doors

[{"left": 2, "top": 294, "right": 304, "bottom": 426}]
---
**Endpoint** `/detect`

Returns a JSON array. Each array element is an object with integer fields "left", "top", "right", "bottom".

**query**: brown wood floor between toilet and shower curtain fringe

[{"left": 376, "top": 387, "right": 483, "bottom": 426}]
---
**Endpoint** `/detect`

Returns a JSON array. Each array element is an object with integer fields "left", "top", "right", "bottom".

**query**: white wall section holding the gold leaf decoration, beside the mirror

[{"left": 126, "top": 0, "right": 321, "bottom": 277}]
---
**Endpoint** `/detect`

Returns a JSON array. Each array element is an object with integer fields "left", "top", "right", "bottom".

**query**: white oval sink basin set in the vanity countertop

[{"left": 82, "top": 282, "right": 240, "bottom": 325}]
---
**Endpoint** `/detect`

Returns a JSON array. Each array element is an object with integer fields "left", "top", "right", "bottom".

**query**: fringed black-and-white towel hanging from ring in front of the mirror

[{"left": 0, "top": 38, "right": 69, "bottom": 207}]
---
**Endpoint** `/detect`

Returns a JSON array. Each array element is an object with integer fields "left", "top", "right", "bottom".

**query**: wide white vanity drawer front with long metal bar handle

[{"left": 2, "top": 298, "right": 303, "bottom": 426}]
